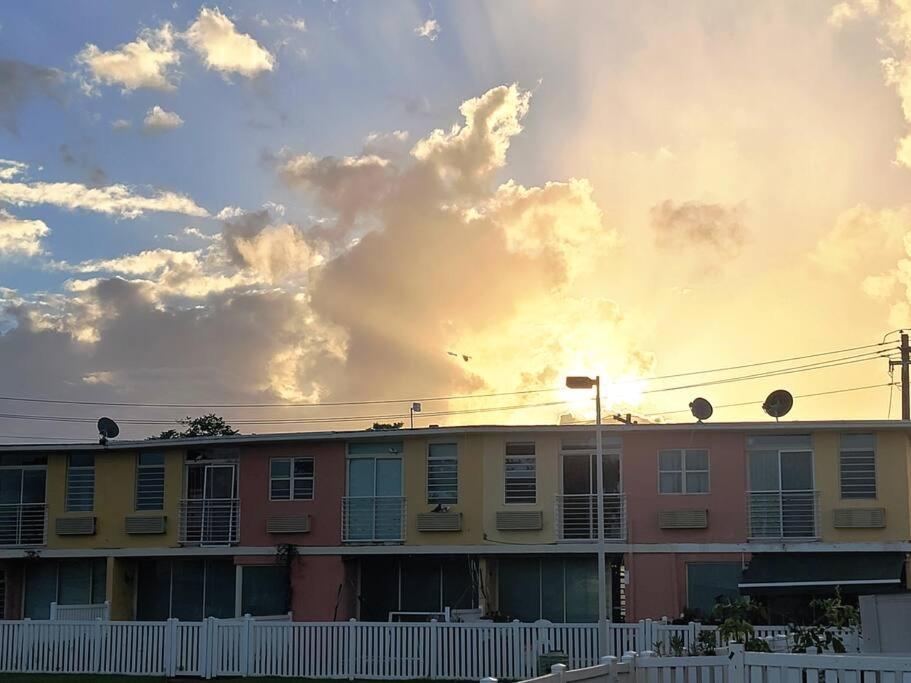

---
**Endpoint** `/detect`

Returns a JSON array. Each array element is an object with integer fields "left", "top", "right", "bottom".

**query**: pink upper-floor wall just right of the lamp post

[{"left": 622, "top": 426, "right": 747, "bottom": 544}]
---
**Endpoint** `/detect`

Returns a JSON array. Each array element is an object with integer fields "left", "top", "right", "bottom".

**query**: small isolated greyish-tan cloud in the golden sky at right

[{"left": 650, "top": 199, "right": 746, "bottom": 257}]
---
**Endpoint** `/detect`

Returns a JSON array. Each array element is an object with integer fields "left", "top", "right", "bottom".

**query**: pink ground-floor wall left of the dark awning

[{"left": 624, "top": 553, "right": 748, "bottom": 621}]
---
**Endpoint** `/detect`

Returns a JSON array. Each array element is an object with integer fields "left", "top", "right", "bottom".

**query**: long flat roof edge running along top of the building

[{"left": 0, "top": 420, "right": 911, "bottom": 453}]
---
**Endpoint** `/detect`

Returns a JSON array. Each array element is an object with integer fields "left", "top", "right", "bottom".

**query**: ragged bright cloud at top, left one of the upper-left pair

[{"left": 76, "top": 24, "right": 180, "bottom": 92}]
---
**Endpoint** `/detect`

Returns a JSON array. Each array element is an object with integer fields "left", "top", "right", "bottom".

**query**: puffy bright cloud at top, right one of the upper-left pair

[{"left": 184, "top": 7, "right": 275, "bottom": 78}]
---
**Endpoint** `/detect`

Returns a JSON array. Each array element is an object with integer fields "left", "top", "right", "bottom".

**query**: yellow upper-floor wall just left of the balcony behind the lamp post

[{"left": 477, "top": 432, "right": 560, "bottom": 543}]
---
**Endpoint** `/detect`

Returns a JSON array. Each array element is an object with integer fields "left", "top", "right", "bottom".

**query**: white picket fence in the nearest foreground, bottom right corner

[{"left": 502, "top": 645, "right": 911, "bottom": 683}]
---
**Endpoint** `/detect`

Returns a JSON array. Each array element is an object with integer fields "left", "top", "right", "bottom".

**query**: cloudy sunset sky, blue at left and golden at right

[{"left": 0, "top": 0, "right": 911, "bottom": 443}]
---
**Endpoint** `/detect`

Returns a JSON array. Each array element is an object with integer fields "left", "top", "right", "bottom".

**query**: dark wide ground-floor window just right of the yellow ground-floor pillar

[{"left": 136, "top": 558, "right": 235, "bottom": 621}]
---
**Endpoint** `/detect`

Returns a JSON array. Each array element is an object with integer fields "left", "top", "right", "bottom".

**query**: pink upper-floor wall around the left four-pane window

[{"left": 239, "top": 441, "right": 345, "bottom": 546}]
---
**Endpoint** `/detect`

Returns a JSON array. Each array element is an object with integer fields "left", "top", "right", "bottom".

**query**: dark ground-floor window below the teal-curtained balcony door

[{"left": 358, "top": 556, "right": 478, "bottom": 621}]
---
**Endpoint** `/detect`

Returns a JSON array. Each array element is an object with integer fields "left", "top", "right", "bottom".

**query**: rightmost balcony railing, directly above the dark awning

[{"left": 747, "top": 490, "right": 819, "bottom": 541}]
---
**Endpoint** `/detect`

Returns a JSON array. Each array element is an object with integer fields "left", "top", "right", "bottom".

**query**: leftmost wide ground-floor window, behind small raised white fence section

[{"left": 24, "top": 557, "right": 107, "bottom": 619}]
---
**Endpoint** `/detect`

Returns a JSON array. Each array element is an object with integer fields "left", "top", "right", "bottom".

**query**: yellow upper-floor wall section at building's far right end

[{"left": 813, "top": 431, "right": 911, "bottom": 543}]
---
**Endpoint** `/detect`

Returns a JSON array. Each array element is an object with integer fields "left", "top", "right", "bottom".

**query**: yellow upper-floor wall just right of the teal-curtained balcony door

[{"left": 403, "top": 435, "right": 484, "bottom": 545}]
